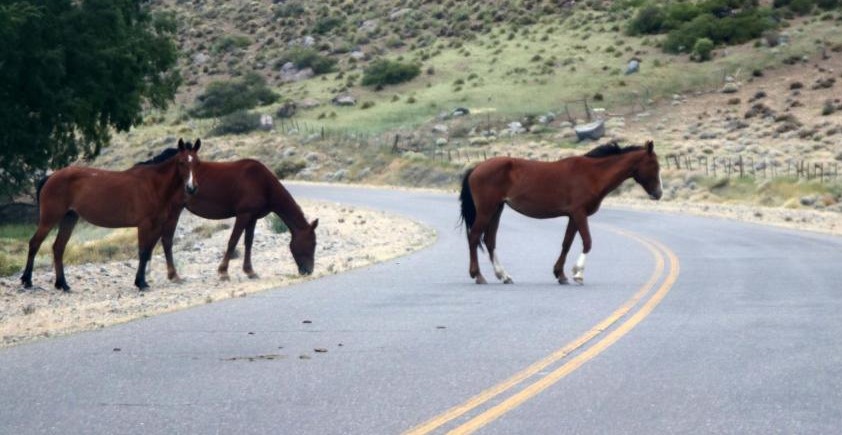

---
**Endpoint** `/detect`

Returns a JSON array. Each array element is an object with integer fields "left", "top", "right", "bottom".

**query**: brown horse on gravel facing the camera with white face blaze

[{"left": 20, "top": 140, "right": 199, "bottom": 291}]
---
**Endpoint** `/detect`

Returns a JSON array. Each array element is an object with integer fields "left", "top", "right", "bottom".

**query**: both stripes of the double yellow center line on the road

[{"left": 405, "top": 229, "right": 679, "bottom": 435}]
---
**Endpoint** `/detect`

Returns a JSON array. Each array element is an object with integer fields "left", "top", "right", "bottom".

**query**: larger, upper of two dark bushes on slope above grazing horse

[{"left": 190, "top": 72, "right": 278, "bottom": 118}]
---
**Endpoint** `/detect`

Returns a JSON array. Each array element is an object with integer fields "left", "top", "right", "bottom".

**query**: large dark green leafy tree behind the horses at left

[{"left": 0, "top": 0, "right": 180, "bottom": 197}]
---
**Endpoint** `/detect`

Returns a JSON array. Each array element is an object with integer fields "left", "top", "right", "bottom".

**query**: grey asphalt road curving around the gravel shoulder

[{"left": 0, "top": 186, "right": 842, "bottom": 434}]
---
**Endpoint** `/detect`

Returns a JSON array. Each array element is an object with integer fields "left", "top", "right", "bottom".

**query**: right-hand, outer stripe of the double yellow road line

[{"left": 449, "top": 241, "right": 680, "bottom": 435}]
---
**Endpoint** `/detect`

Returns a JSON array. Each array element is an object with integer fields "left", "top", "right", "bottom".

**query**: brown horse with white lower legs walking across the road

[{"left": 460, "top": 141, "right": 661, "bottom": 284}]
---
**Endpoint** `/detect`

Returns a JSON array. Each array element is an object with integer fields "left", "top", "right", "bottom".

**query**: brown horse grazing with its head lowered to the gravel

[{"left": 163, "top": 152, "right": 319, "bottom": 280}]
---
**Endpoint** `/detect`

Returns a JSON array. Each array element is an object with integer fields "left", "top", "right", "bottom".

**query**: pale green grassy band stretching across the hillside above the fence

[{"left": 268, "top": 12, "right": 842, "bottom": 133}]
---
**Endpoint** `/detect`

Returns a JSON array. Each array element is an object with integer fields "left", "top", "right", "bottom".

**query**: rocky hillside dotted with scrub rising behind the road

[{"left": 108, "top": 0, "right": 842, "bottom": 206}]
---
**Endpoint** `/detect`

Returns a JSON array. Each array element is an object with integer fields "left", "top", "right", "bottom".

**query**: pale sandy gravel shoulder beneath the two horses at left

[{"left": 0, "top": 201, "right": 436, "bottom": 347}]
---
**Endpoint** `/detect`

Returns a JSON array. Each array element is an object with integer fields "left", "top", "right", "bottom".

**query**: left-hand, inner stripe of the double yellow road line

[{"left": 405, "top": 229, "right": 664, "bottom": 435}]
